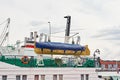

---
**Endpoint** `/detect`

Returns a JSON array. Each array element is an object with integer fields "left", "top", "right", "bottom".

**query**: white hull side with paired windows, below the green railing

[{"left": 0, "top": 68, "right": 99, "bottom": 80}]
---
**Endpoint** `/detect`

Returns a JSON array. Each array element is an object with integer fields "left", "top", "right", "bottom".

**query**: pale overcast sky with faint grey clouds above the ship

[{"left": 0, "top": 0, "right": 120, "bottom": 60}]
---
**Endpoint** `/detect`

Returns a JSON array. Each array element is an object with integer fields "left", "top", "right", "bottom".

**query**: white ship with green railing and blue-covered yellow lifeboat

[{"left": 0, "top": 16, "right": 111, "bottom": 80}]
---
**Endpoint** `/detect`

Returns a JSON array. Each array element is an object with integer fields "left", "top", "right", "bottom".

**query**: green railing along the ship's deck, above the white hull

[{"left": 0, "top": 56, "right": 94, "bottom": 67}]
